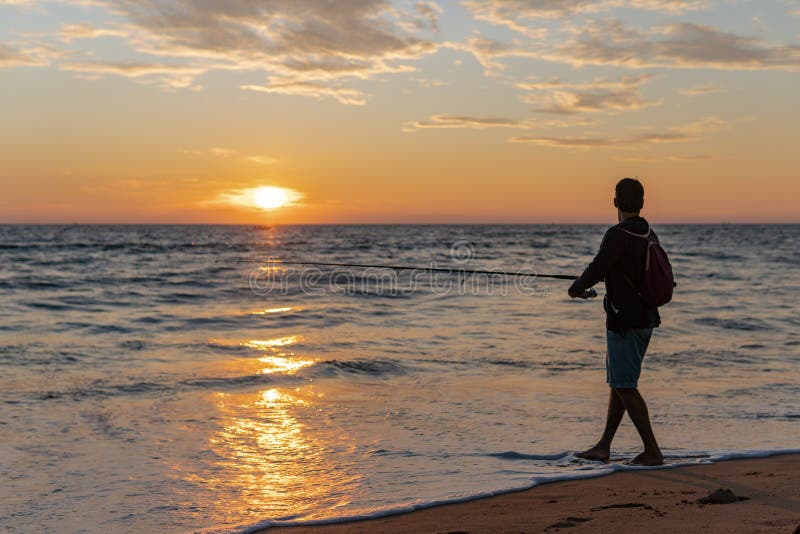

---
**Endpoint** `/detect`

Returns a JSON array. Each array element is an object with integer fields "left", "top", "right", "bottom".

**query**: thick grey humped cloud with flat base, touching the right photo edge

[{"left": 543, "top": 20, "right": 800, "bottom": 70}]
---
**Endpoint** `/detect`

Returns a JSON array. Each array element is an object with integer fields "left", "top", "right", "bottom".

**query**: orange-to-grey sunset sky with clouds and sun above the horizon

[{"left": 0, "top": 0, "right": 800, "bottom": 224}]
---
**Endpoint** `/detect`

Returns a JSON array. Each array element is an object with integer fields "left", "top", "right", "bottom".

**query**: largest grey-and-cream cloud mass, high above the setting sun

[{"left": 61, "top": 0, "right": 441, "bottom": 101}]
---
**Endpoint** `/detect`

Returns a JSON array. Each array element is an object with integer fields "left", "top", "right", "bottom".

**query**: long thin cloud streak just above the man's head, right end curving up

[{"left": 508, "top": 117, "right": 724, "bottom": 150}]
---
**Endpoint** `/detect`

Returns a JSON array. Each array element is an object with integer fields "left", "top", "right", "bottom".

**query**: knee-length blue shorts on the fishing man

[{"left": 606, "top": 328, "right": 653, "bottom": 388}]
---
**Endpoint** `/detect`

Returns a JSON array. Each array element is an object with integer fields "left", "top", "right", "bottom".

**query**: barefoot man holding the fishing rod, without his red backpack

[{"left": 569, "top": 178, "right": 664, "bottom": 465}]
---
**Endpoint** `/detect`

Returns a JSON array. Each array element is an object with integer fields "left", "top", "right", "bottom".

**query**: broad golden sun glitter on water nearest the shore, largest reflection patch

[{"left": 184, "top": 387, "right": 360, "bottom": 522}]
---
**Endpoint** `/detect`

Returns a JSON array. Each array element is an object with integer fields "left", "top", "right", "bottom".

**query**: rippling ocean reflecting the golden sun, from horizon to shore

[{"left": 0, "top": 225, "right": 800, "bottom": 532}]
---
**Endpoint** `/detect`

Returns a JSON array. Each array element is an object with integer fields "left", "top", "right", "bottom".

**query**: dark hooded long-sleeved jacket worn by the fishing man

[{"left": 570, "top": 217, "right": 661, "bottom": 332}]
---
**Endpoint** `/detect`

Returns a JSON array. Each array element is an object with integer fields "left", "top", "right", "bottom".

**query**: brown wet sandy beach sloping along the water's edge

[{"left": 262, "top": 455, "right": 800, "bottom": 534}]
